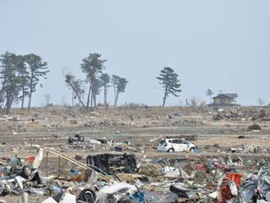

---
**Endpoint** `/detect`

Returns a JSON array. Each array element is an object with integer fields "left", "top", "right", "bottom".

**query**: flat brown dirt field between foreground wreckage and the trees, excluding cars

[{"left": 0, "top": 107, "right": 270, "bottom": 202}]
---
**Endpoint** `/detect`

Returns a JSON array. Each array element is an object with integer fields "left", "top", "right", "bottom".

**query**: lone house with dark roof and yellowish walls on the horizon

[{"left": 208, "top": 93, "right": 240, "bottom": 112}]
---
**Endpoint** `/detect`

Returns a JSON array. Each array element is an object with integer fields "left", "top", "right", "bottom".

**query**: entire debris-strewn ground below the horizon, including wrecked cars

[{"left": 0, "top": 106, "right": 270, "bottom": 203}]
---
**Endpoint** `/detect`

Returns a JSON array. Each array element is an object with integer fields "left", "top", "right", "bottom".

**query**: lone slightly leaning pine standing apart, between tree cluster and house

[{"left": 157, "top": 67, "right": 182, "bottom": 106}]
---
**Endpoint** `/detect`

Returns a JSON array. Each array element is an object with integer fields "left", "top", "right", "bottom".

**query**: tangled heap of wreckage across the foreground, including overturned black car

[{"left": 0, "top": 146, "right": 270, "bottom": 203}]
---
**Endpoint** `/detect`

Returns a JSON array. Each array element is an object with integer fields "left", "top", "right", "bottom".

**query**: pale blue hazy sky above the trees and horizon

[{"left": 0, "top": 0, "right": 270, "bottom": 106}]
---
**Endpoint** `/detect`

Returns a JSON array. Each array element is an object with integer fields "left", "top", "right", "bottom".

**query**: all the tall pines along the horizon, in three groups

[{"left": 0, "top": 52, "right": 184, "bottom": 114}]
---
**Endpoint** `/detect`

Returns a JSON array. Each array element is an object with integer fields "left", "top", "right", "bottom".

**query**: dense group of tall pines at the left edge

[{"left": 0, "top": 52, "right": 49, "bottom": 114}]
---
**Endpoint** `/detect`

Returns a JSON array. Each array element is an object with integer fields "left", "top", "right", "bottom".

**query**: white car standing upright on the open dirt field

[{"left": 157, "top": 138, "right": 197, "bottom": 152}]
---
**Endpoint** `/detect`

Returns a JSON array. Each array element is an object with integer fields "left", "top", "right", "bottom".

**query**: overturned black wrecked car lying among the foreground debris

[{"left": 86, "top": 153, "right": 139, "bottom": 174}]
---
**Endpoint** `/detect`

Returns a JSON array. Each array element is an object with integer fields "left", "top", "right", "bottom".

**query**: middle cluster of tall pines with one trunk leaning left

[{"left": 65, "top": 53, "right": 128, "bottom": 110}]
